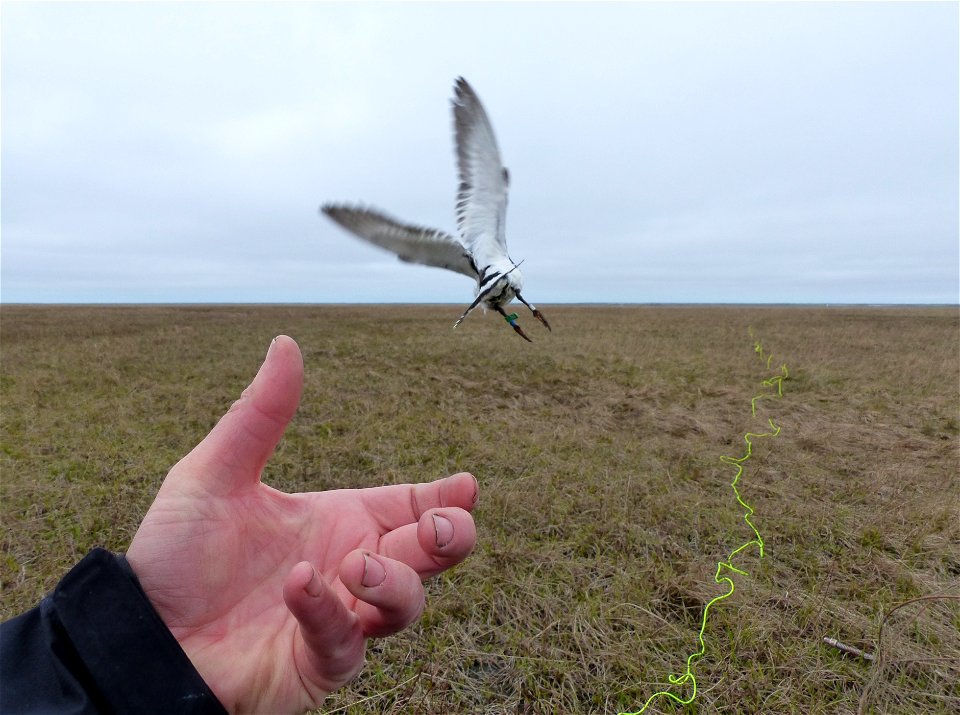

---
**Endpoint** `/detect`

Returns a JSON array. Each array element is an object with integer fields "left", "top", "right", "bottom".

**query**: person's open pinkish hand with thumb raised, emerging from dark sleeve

[{"left": 127, "top": 336, "right": 477, "bottom": 713}]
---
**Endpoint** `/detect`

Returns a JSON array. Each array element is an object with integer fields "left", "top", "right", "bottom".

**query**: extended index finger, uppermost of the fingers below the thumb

[{"left": 361, "top": 472, "right": 479, "bottom": 531}]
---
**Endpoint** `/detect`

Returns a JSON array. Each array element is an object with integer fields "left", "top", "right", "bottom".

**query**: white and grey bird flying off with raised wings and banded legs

[{"left": 320, "top": 77, "right": 553, "bottom": 342}]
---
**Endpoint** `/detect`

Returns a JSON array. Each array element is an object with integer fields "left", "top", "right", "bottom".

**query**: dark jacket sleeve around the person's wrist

[{"left": 0, "top": 549, "right": 226, "bottom": 715}]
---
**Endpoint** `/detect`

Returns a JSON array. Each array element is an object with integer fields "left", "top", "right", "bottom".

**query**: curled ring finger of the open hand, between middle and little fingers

[{"left": 340, "top": 550, "right": 425, "bottom": 638}]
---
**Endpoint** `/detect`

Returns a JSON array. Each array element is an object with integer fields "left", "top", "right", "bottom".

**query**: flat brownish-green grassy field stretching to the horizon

[{"left": 0, "top": 306, "right": 960, "bottom": 714}]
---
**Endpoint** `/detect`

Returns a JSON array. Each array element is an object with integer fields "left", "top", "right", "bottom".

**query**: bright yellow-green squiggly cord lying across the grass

[{"left": 619, "top": 336, "right": 789, "bottom": 715}]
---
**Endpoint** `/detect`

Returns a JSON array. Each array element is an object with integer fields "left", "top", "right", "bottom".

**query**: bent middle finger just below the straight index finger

[{"left": 377, "top": 507, "right": 477, "bottom": 579}]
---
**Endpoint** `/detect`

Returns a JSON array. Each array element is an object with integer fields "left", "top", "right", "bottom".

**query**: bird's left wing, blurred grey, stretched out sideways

[{"left": 321, "top": 204, "right": 477, "bottom": 279}]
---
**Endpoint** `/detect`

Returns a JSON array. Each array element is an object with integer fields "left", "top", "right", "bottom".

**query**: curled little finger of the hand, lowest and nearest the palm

[{"left": 283, "top": 561, "right": 364, "bottom": 700}]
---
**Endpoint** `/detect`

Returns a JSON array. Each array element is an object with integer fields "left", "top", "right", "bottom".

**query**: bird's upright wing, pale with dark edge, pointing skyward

[{"left": 453, "top": 77, "right": 509, "bottom": 271}]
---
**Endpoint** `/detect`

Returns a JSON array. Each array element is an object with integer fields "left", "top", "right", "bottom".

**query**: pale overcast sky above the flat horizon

[{"left": 0, "top": 2, "right": 960, "bottom": 304}]
